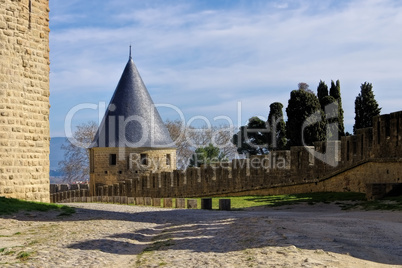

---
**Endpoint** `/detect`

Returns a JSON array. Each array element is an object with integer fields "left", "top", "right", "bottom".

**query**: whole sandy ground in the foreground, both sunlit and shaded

[{"left": 0, "top": 203, "right": 402, "bottom": 268}]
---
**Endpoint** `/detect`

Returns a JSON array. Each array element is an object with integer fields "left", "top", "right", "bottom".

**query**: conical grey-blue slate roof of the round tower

[{"left": 91, "top": 55, "right": 175, "bottom": 148}]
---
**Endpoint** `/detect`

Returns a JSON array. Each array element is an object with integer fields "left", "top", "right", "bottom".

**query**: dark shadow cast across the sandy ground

[{"left": 2, "top": 204, "right": 402, "bottom": 265}]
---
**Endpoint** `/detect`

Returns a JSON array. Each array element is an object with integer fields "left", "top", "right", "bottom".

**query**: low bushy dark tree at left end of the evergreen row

[{"left": 232, "top": 116, "right": 268, "bottom": 155}]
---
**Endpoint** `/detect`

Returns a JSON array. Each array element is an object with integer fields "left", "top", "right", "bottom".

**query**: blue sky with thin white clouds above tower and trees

[{"left": 50, "top": 0, "right": 402, "bottom": 137}]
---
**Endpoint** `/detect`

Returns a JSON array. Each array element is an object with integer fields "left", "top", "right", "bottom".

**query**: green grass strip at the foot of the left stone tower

[{"left": 0, "top": 197, "right": 75, "bottom": 216}]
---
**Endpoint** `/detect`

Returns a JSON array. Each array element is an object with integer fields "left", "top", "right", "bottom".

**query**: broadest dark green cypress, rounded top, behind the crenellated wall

[{"left": 286, "top": 83, "right": 325, "bottom": 146}]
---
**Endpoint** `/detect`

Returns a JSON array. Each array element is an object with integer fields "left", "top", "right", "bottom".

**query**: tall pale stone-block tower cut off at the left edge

[{"left": 0, "top": 0, "right": 50, "bottom": 202}]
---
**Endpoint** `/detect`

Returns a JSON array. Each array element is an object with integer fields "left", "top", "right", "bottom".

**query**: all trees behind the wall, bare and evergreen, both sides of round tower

[{"left": 59, "top": 80, "right": 381, "bottom": 183}]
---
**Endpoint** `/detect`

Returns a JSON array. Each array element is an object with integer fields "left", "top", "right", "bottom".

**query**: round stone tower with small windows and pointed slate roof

[{"left": 89, "top": 52, "right": 176, "bottom": 195}]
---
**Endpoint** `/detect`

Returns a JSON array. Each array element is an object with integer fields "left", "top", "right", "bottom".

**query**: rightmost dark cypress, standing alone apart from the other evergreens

[{"left": 353, "top": 82, "right": 381, "bottom": 134}]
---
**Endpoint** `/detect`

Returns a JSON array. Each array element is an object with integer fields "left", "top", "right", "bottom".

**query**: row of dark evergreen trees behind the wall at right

[{"left": 232, "top": 80, "right": 381, "bottom": 156}]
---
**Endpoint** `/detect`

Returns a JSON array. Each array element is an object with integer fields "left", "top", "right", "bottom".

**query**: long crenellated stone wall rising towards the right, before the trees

[{"left": 52, "top": 112, "right": 402, "bottom": 201}]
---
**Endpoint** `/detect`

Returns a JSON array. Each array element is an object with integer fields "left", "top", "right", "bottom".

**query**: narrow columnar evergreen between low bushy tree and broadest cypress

[{"left": 267, "top": 102, "right": 287, "bottom": 150}]
